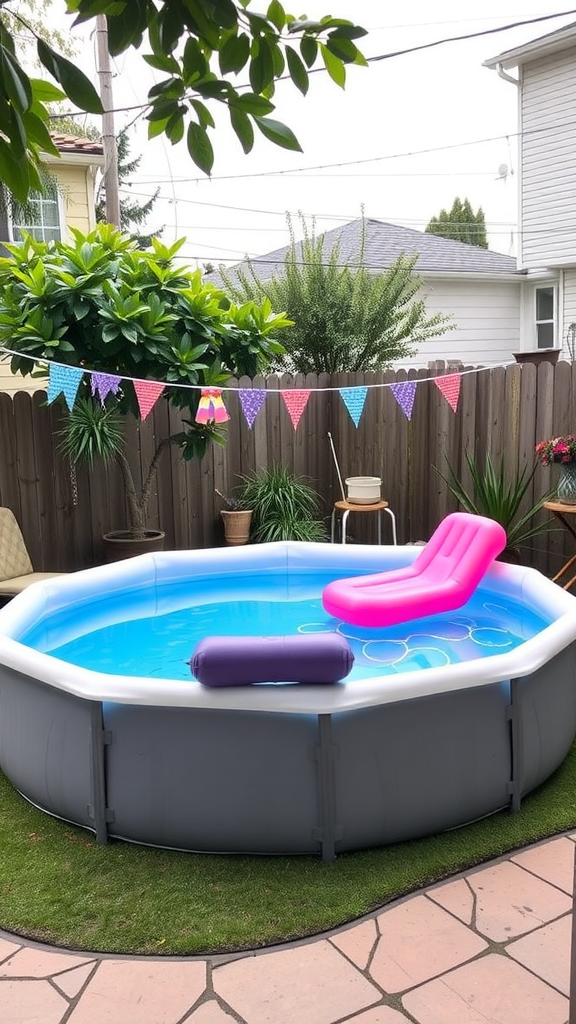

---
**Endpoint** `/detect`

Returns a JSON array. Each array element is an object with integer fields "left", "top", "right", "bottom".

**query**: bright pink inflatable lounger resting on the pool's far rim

[{"left": 322, "top": 512, "right": 506, "bottom": 628}]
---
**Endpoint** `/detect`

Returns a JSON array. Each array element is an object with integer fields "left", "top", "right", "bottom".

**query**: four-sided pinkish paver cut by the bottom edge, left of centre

[{"left": 66, "top": 961, "right": 206, "bottom": 1024}]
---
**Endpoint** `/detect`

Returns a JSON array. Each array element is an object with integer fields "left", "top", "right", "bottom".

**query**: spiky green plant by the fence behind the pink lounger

[{"left": 434, "top": 453, "right": 551, "bottom": 562}]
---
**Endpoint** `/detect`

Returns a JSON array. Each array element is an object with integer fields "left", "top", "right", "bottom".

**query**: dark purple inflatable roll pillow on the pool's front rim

[{"left": 190, "top": 633, "right": 354, "bottom": 686}]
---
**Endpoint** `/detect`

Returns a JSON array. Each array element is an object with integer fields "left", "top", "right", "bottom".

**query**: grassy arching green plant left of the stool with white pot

[{"left": 236, "top": 466, "right": 327, "bottom": 543}]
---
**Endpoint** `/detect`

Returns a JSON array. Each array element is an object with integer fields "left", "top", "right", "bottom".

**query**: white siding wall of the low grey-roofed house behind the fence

[{"left": 396, "top": 279, "right": 522, "bottom": 367}]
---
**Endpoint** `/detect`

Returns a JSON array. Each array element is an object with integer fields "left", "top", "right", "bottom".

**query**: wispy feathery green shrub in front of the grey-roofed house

[{"left": 220, "top": 215, "right": 452, "bottom": 374}]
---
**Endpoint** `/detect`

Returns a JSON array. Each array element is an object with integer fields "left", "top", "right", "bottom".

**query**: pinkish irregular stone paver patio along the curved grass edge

[{"left": 0, "top": 834, "right": 576, "bottom": 1024}]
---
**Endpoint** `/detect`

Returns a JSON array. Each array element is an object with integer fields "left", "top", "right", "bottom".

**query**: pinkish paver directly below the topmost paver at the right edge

[{"left": 468, "top": 861, "right": 572, "bottom": 942}]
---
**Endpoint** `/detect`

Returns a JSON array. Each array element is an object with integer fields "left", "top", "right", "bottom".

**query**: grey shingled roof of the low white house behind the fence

[{"left": 213, "top": 218, "right": 519, "bottom": 280}]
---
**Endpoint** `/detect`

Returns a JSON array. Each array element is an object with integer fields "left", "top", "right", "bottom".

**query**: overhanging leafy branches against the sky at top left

[{"left": 0, "top": 0, "right": 366, "bottom": 202}]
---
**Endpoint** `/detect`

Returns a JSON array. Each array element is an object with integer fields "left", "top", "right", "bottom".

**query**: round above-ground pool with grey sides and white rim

[{"left": 0, "top": 544, "right": 576, "bottom": 859}]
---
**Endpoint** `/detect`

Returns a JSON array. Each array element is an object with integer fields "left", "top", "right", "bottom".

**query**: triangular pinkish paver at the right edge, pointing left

[{"left": 506, "top": 914, "right": 572, "bottom": 995}]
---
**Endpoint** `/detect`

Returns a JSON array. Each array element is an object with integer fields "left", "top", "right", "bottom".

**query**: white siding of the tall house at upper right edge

[{"left": 519, "top": 45, "right": 576, "bottom": 269}]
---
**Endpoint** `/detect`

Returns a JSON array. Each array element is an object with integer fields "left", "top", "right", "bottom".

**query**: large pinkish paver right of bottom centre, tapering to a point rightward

[{"left": 370, "top": 896, "right": 487, "bottom": 992}]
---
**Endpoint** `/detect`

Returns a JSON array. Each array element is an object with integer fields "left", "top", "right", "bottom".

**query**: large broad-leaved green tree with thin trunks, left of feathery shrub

[{"left": 0, "top": 224, "right": 290, "bottom": 553}]
